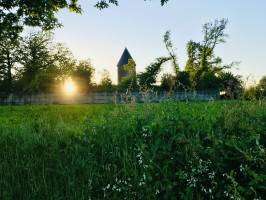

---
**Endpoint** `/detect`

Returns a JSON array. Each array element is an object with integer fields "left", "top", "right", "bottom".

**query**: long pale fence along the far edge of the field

[{"left": 0, "top": 91, "right": 219, "bottom": 105}]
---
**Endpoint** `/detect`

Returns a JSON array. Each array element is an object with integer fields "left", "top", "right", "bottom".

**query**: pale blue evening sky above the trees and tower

[{"left": 54, "top": 0, "right": 266, "bottom": 83}]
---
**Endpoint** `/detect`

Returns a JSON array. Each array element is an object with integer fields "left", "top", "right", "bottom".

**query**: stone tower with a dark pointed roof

[{"left": 117, "top": 48, "right": 136, "bottom": 84}]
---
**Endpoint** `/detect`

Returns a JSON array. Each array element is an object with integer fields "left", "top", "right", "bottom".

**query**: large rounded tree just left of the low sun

[{"left": 17, "top": 32, "right": 77, "bottom": 94}]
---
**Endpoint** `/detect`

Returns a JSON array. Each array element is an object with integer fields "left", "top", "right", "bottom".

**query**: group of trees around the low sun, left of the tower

[{"left": 0, "top": 32, "right": 94, "bottom": 94}]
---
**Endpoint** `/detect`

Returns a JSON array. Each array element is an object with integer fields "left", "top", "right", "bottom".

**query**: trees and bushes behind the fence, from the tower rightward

[{"left": 117, "top": 19, "right": 266, "bottom": 100}]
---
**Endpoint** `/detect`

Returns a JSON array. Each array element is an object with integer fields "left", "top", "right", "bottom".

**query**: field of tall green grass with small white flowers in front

[{"left": 0, "top": 101, "right": 266, "bottom": 200}]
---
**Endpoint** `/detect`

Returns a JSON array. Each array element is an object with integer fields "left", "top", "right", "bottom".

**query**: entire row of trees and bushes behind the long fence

[{"left": 0, "top": 19, "right": 266, "bottom": 99}]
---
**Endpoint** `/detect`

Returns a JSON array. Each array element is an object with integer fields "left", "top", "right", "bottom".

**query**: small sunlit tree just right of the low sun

[{"left": 71, "top": 60, "right": 95, "bottom": 93}]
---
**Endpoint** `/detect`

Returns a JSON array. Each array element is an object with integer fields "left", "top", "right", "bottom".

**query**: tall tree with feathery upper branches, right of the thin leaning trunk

[{"left": 185, "top": 19, "right": 231, "bottom": 89}]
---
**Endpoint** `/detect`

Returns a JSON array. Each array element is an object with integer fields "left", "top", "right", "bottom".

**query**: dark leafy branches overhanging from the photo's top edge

[{"left": 0, "top": 0, "right": 168, "bottom": 40}]
